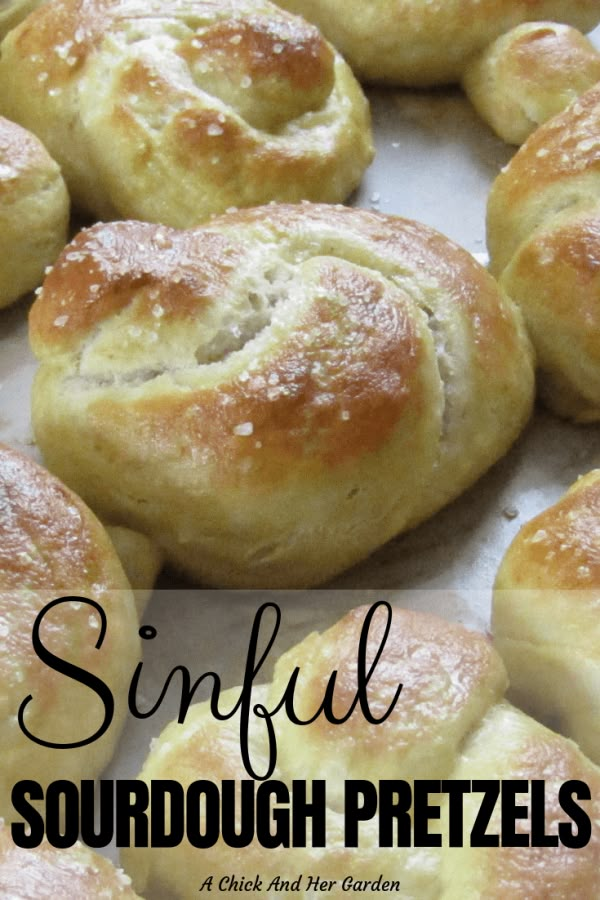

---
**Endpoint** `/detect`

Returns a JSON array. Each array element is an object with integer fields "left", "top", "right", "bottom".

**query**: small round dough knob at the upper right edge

[{"left": 462, "top": 22, "right": 600, "bottom": 144}]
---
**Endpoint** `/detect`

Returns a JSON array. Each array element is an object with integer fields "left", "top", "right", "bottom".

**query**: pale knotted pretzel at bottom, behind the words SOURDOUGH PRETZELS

[{"left": 123, "top": 608, "right": 600, "bottom": 900}]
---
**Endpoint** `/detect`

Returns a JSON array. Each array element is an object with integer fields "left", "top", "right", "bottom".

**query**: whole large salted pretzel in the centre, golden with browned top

[{"left": 30, "top": 204, "right": 532, "bottom": 588}]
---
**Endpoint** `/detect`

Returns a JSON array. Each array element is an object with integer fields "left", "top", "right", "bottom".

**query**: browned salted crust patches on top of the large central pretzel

[{"left": 30, "top": 205, "right": 514, "bottom": 474}]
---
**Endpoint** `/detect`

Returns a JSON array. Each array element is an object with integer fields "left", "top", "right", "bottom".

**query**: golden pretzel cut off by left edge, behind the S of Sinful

[{"left": 0, "top": 446, "right": 140, "bottom": 817}]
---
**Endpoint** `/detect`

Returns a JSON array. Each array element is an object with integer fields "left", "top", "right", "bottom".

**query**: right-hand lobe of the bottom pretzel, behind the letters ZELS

[{"left": 440, "top": 703, "right": 600, "bottom": 900}]
